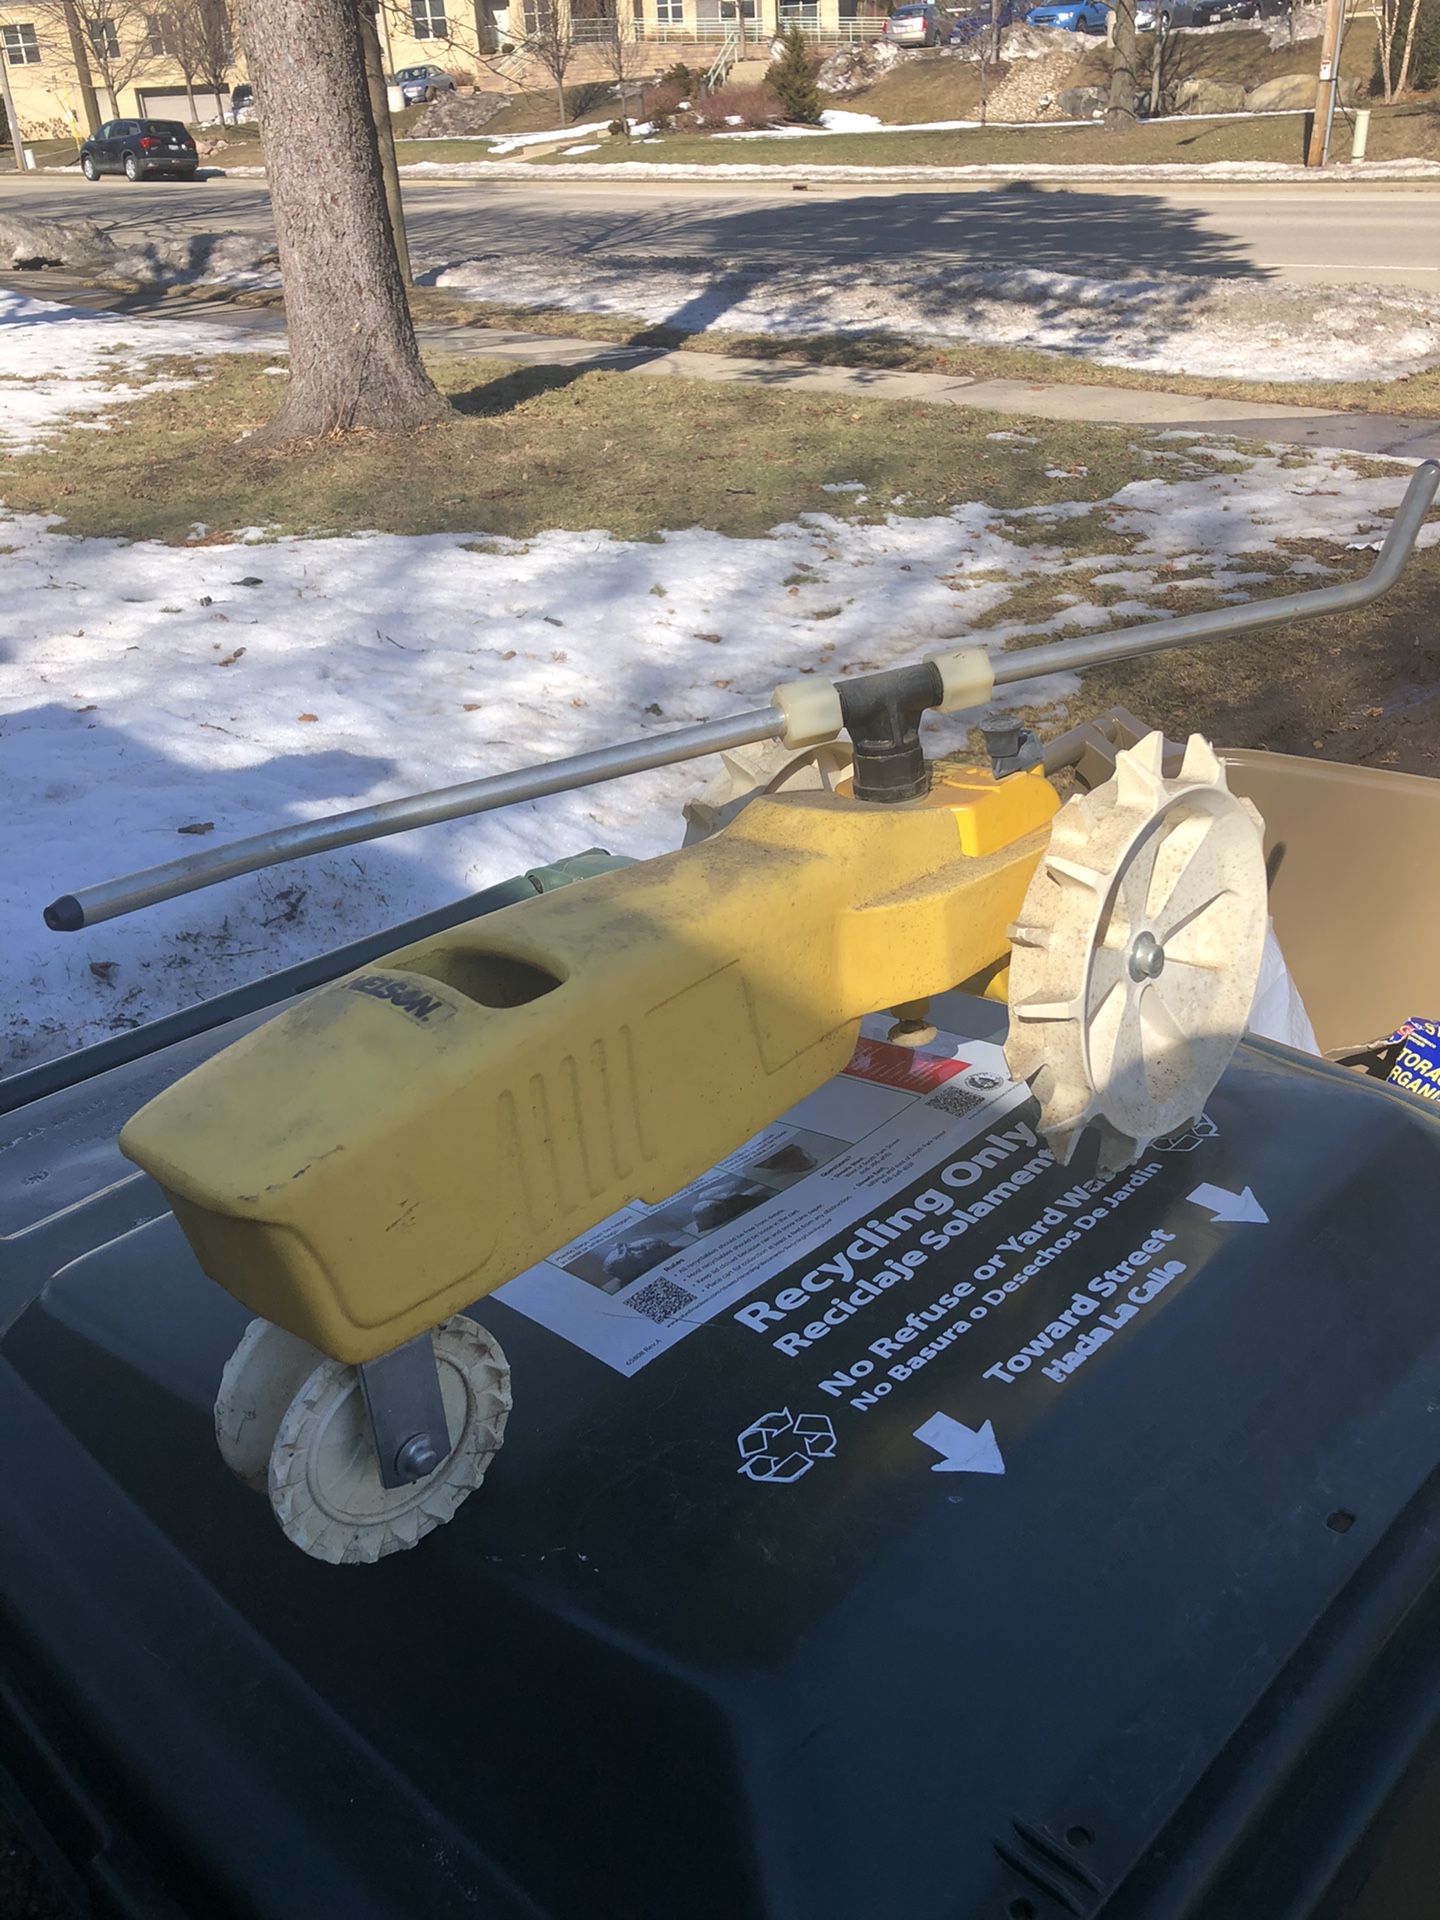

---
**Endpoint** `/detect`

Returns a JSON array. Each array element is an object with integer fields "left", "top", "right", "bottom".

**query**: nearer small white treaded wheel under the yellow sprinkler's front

[{"left": 269, "top": 1313, "right": 511, "bottom": 1567}]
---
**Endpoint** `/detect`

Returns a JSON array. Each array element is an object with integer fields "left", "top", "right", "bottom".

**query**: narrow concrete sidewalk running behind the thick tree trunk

[{"left": 11, "top": 269, "right": 1440, "bottom": 459}]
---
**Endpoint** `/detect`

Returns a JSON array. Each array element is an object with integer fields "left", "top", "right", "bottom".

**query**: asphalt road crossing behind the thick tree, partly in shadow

[{"left": 0, "top": 175, "right": 1440, "bottom": 294}]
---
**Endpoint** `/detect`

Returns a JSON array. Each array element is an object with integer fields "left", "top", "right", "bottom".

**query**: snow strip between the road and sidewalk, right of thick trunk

[{"left": 436, "top": 253, "right": 1440, "bottom": 380}]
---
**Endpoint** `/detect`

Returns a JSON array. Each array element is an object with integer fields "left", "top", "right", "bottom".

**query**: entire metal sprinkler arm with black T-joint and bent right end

[{"left": 44, "top": 461, "right": 1440, "bottom": 933}]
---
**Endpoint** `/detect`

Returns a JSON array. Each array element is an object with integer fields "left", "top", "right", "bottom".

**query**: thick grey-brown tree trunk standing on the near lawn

[{"left": 240, "top": 0, "right": 447, "bottom": 444}]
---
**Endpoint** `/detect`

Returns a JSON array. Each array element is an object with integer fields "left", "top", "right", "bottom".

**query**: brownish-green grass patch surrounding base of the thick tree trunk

[{"left": 4, "top": 355, "right": 1150, "bottom": 553}]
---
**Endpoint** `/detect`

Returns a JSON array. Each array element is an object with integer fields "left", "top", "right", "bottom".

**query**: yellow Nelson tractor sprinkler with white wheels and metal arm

[{"left": 39, "top": 465, "right": 1440, "bottom": 1566}]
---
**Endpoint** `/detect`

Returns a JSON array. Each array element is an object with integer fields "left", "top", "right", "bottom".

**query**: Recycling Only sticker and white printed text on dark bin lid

[{"left": 501, "top": 1031, "right": 1269, "bottom": 1505}]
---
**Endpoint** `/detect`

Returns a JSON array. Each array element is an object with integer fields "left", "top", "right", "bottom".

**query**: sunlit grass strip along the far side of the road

[{"left": 532, "top": 102, "right": 1440, "bottom": 169}]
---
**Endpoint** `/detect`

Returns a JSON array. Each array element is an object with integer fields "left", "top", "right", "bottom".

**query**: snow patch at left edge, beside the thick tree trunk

[{"left": 0, "top": 288, "right": 275, "bottom": 447}]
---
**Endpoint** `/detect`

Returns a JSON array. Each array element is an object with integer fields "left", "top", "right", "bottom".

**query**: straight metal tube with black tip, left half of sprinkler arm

[{"left": 44, "top": 707, "right": 785, "bottom": 933}]
